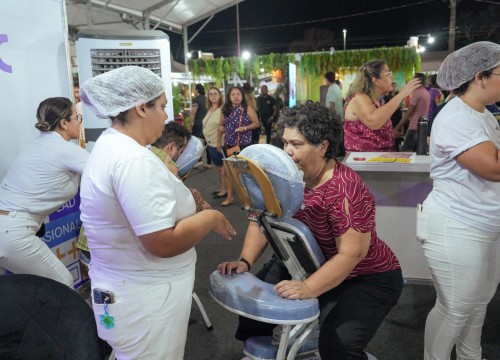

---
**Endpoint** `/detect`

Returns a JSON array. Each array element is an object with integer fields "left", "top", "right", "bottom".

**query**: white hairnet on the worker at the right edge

[{"left": 437, "top": 41, "right": 500, "bottom": 90}]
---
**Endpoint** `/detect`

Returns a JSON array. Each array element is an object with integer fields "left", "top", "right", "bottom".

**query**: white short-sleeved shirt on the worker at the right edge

[{"left": 427, "top": 97, "right": 500, "bottom": 232}]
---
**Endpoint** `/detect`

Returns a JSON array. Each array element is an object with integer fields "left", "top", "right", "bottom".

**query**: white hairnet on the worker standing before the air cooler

[{"left": 80, "top": 66, "right": 165, "bottom": 118}]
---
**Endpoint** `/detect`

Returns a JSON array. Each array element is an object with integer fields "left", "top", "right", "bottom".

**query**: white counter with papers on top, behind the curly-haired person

[{"left": 344, "top": 152, "right": 432, "bottom": 282}]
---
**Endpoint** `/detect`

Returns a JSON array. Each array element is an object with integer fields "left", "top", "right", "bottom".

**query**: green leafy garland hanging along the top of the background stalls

[{"left": 189, "top": 46, "right": 421, "bottom": 85}]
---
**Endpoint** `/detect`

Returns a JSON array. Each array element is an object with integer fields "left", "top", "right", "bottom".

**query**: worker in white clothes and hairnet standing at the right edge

[{"left": 417, "top": 41, "right": 500, "bottom": 360}]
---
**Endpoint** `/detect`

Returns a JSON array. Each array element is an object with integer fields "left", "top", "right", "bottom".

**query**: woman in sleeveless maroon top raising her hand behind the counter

[{"left": 344, "top": 59, "right": 421, "bottom": 151}]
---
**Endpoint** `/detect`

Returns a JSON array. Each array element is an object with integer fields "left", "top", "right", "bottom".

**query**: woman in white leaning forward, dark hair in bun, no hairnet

[{"left": 0, "top": 97, "right": 88, "bottom": 287}]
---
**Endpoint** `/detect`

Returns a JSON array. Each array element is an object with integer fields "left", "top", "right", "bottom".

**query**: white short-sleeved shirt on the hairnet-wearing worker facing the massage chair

[{"left": 80, "top": 128, "right": 196, "bottom": 284}]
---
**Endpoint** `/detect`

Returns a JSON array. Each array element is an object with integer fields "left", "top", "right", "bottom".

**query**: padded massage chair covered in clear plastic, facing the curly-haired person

[{"left": 209, "top": 145, "right": 325, "bottom": 360}]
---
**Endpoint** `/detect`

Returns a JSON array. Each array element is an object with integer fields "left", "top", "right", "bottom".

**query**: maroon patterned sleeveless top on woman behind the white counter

[{"left": 344, "top": 95, "right": 395, "bottom": 152}]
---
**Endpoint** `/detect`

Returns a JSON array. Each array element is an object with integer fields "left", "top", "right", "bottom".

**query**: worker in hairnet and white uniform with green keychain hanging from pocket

[{"left": 80, "top": 66, "right": 235, "bottom": 360}]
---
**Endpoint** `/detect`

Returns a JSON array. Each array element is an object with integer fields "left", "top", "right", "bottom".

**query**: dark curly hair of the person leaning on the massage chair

[{"left": 278, "top": 104, "right": 342, "bottom": 159}]
